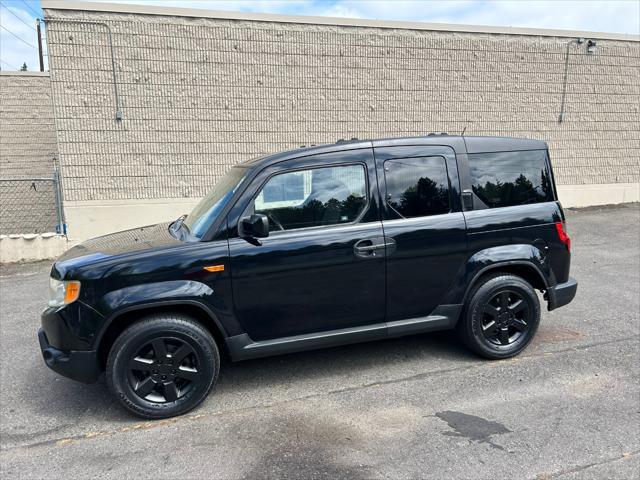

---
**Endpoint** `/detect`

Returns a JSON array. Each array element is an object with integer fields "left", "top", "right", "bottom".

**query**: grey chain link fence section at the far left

[{"left": 0, "top": 170, "right": 66, "bottom": 235}]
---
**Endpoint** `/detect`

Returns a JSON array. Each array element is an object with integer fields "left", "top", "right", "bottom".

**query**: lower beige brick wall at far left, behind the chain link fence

[{"left": 0, "top": 72, "right": 58, "bottom": 234}]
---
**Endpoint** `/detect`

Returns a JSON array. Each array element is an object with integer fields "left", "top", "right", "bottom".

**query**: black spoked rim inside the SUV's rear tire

[{"left": 482, "top": 290, "right": 531, "bottom": 346}]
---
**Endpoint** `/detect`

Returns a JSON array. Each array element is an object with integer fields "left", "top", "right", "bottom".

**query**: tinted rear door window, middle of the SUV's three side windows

[{"left": 384, "top": 157, "right": 451, "bottom": 218}]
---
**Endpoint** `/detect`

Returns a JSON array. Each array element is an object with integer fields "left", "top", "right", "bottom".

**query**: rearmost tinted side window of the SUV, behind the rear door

[{"left": 469, "top": 150, "right": 554, "bottom": 208}]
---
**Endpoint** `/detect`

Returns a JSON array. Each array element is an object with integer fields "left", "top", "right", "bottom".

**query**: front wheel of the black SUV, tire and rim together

[{"left": 106, "top": 313, "right": 220, "bottom": 419}]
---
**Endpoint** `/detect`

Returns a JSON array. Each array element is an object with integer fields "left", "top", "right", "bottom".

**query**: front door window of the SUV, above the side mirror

[{"left": 253, "top": 165, "right": 367, "bottom": 231}]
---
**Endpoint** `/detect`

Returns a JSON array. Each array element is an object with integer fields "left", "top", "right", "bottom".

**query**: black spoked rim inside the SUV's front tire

[{"left": 127, "top": 337, "right": 200, "bottom": 403}]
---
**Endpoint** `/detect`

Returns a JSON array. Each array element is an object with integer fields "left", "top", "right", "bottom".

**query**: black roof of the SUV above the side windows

[{"left": 238, "top": 134, "right": 547, "bottom": 168}]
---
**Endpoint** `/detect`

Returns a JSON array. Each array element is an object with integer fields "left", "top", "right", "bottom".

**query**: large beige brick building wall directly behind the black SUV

[{"left": 42, "top": 0, "right": 640, "bottom": 238}]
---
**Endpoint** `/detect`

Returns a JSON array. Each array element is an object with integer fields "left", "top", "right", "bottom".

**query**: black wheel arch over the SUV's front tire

[{"left": 96, "top": 300, "right": 228, "bottom": 370}]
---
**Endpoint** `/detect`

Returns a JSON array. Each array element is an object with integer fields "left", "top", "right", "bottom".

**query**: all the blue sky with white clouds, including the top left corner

[{"left": 0, "top": 0, "right": 640, "bottom": 71}]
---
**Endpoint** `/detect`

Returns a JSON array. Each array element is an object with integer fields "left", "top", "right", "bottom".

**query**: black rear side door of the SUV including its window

[{"left": 375, "top": 146, "right": 466, "bottom": 320}]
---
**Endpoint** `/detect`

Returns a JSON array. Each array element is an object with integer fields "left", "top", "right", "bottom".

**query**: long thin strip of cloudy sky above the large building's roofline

[{"left": 86, "top": 0, "right": 640, "bottom": 35}]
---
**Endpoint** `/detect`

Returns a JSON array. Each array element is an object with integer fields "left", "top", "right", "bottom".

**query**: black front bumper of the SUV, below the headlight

[{"left": 38, "top": 328, "right": 101, "bottom": 383}]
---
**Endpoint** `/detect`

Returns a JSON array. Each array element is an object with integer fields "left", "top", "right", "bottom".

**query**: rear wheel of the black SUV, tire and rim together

[{"left": 457, "top": 273, "right": 540, "bottom": 359}]
